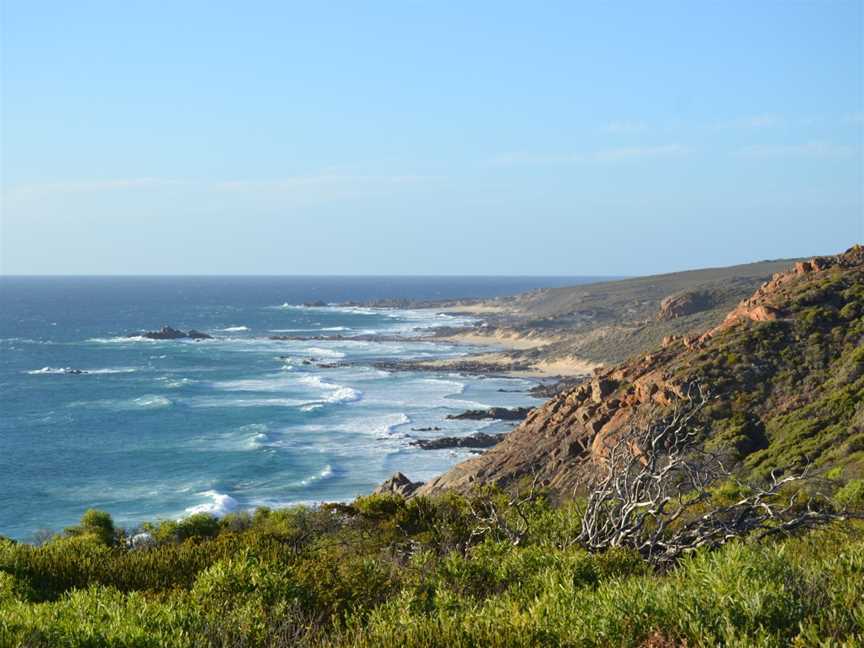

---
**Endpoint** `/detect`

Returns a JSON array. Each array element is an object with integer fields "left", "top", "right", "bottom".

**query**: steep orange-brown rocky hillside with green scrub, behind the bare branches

[{"left": 417, "top": 246, "right": 864, "bottom": 494}]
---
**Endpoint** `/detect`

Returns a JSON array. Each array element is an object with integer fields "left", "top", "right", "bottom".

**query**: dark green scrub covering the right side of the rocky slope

[{"left": 671, "top": 260, "right": 864, "bottom": 480}]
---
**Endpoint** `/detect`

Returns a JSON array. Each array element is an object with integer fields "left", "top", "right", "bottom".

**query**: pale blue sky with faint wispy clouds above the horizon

[{"left": 0, "top": 0, "right": 864, "bottom": 275}]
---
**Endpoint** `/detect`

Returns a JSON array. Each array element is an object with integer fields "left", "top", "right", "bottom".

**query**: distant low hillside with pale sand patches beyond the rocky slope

[{"left": 432, "top": 260, "right": 794, "bottom": 375}]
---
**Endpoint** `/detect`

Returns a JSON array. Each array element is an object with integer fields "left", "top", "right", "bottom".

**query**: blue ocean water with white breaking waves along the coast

[{"left": 0, "top": 277, "right": 587, "bottom": 539}]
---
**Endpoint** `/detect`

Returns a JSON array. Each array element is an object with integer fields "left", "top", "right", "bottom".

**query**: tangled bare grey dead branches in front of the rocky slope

[{"left": 578, "top": 384, "right": 847, "bottom": 566}]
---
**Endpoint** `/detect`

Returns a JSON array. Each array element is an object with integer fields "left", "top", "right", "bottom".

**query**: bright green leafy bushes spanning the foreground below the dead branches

[{"left": 0, "top": 486, "right": 864, "bottom": 647}]
